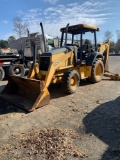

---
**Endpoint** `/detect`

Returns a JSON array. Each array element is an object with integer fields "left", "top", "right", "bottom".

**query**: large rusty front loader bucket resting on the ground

[{"left": 0, "top": 76, "right": 50, "bottom": 111}]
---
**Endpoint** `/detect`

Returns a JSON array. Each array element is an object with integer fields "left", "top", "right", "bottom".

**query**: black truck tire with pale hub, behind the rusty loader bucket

[{"left": 9, "top": 64, "right": 25, "bottom": 77}]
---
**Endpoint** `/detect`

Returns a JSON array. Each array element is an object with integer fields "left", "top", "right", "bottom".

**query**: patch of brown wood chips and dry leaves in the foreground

[{"left": 0, "top": 128, "right": 85, "bottom": 160}]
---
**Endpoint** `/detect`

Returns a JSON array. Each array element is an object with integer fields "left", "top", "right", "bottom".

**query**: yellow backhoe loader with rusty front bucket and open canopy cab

[{"left": 0, "top": 23, "right": 118, "bottom": 111}]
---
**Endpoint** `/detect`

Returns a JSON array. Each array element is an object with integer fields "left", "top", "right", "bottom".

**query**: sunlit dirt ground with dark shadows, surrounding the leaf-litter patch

[{"left": 0, "top": 56, "right": 120, "bottom": 160}]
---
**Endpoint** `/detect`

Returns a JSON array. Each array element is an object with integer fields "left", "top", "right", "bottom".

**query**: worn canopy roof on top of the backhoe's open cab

[{"left": 60, "top": 24, "right": 99, "bottom": 34}]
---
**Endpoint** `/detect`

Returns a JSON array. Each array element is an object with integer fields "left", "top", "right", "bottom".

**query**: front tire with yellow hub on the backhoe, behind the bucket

[{"left": 63, "top": 70, "right": 80, "bottom": 94}]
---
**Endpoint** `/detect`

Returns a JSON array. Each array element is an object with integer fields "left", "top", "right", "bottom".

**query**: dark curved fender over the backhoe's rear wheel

[{"left": 86, "top": 52, "right": 103, "bottom": 66}]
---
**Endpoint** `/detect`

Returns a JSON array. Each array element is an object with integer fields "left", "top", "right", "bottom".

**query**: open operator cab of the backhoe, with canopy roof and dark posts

[{"left": 60, "top": 24, "right": 99, "bottom": 64}]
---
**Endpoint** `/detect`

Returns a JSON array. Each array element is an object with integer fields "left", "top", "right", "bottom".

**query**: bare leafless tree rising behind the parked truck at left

[{"left": 13, "top": 17, "right": 29, "bottom": 38}]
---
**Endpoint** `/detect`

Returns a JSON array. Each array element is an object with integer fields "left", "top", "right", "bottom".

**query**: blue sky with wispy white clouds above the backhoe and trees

[{"left": 0, "top": 0, "right": 120, "bottom": 42}]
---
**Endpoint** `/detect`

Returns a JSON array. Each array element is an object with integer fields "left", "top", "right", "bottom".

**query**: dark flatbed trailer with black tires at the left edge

[{"left": 0, "top": 48, "right": 25, "bottom": 80}]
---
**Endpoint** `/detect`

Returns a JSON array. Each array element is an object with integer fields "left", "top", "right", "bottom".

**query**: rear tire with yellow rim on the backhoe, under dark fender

[{"left": 88, "top": 60, "right": 104, "bottom": 83}]
